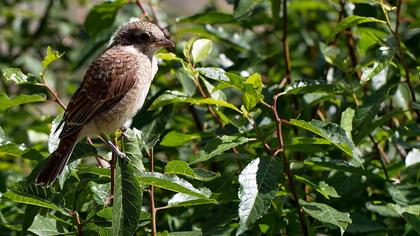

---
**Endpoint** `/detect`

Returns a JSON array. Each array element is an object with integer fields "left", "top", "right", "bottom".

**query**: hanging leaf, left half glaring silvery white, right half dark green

[{"left": 236, "top": 157, "right": 283, "bottom": 235}]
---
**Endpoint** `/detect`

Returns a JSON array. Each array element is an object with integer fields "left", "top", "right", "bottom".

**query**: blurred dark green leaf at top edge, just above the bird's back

[{"left": 84, "top": 0, "right": 128, "bottom": 38}]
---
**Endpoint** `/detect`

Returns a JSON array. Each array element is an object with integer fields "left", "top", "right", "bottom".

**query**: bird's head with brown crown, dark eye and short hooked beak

[{"left": 111, "top": 21, "right": 175, "bottom": 55}]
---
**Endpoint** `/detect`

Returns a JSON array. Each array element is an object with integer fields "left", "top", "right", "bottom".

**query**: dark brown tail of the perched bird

[{"left": 36, "top": 132, "right": 79, "bottom": 186}]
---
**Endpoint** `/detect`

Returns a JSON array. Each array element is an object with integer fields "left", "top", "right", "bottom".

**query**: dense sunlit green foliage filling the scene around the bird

[{"left": 0, "top": 0, "right": 420, "bottom": 235}]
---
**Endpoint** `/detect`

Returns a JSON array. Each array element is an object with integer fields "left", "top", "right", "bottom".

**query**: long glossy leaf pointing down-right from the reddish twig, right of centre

[{"left": 290, "top": 119, "right": 362, "bottom": 167}]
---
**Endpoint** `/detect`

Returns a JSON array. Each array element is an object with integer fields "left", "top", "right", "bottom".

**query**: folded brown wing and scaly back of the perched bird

[{"left": 59, "top": 48, "right": 139, "bottom": 138}]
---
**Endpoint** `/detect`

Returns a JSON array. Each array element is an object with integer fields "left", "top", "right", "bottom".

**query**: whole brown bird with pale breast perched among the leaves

[{"left": 35, "top": 20, "right": 175, "bottom": 186}]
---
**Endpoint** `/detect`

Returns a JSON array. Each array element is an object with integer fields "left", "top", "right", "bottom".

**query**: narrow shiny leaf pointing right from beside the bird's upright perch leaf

[{"left": 138, "top": 172, "right": 210, "bottom": 199}]
